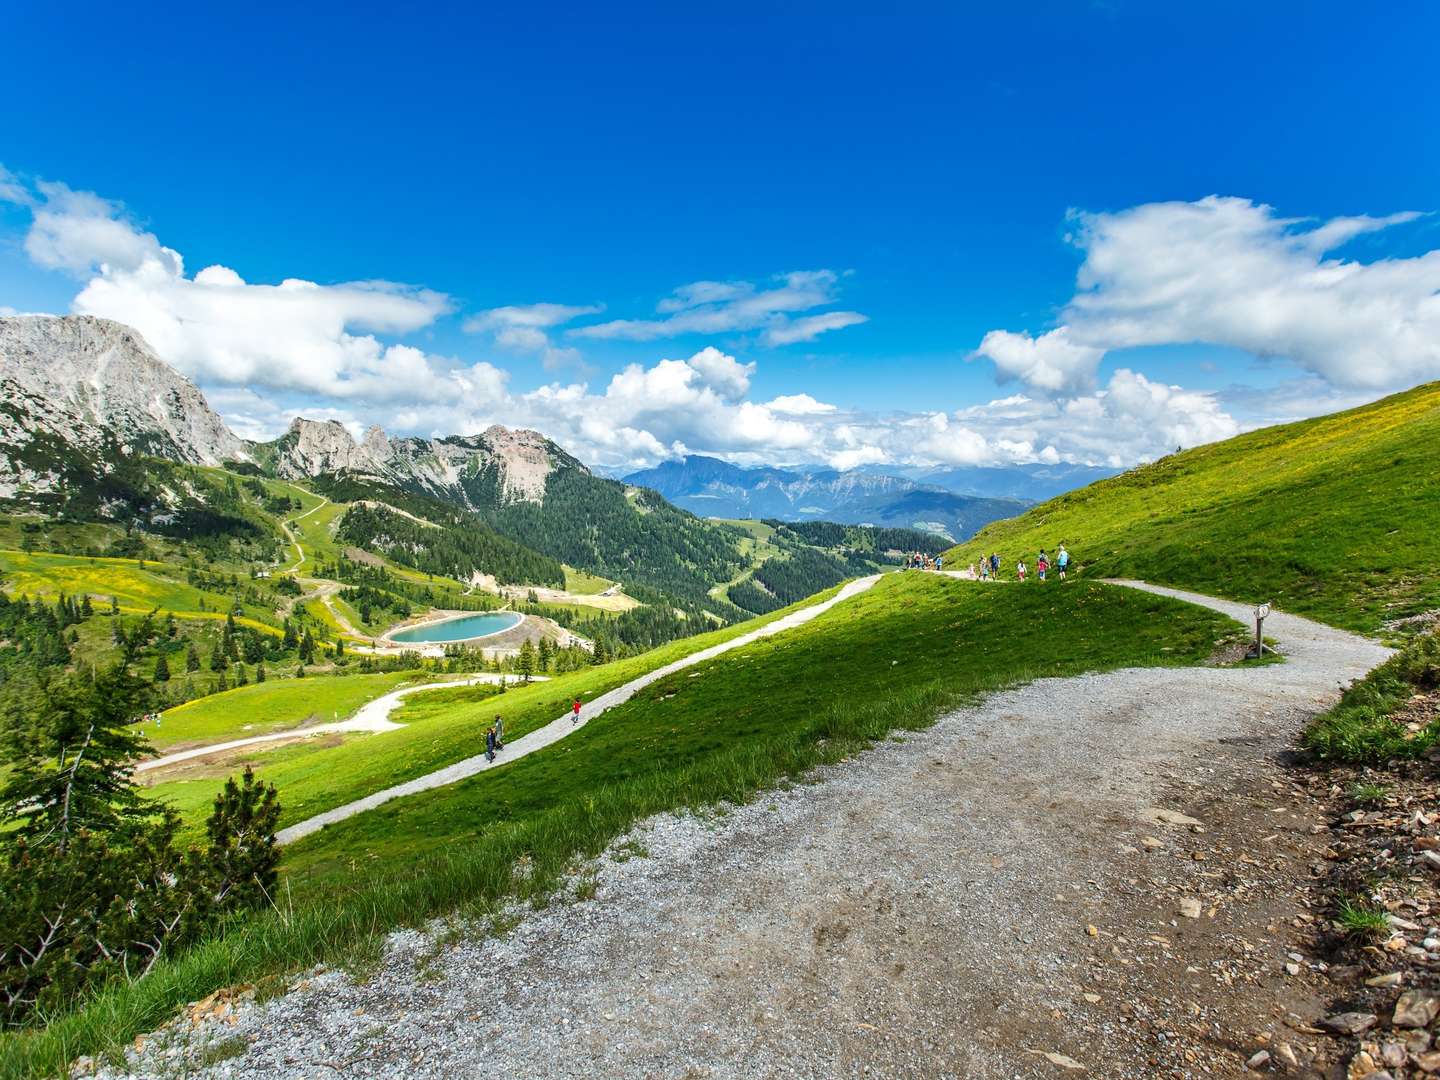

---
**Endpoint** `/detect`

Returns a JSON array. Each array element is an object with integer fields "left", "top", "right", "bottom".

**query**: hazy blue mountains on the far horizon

[{"left": 625, "top": 454, "right": 1048, "bottom": 540}]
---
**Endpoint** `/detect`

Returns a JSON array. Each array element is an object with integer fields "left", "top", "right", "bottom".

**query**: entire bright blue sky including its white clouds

[{"left": 0, "top": 3, "right": 1440, "bottom": 465}]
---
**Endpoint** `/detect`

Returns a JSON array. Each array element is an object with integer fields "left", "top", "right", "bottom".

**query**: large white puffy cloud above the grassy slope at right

[{"left": 976, "top": 196, "right": 1440, "bottom": 390}]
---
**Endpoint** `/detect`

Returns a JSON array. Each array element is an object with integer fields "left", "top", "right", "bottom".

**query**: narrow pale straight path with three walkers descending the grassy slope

[{"left": 275, "top": 575, "right": 880, "bottom": 844}]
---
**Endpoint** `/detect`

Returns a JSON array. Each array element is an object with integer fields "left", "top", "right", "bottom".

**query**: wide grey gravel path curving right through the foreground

[{"left": 104, "top": 585, "right": 1387, "bottom": 1080}]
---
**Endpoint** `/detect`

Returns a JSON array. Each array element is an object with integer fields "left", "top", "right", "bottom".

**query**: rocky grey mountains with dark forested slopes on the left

[{"left": 0, "top": 315, "right": 950, "bottom": 616}]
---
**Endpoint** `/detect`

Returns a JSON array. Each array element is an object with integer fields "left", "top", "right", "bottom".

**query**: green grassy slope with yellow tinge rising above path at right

[{"left": 946, "top": 383, "right": 1440, "bottom": 632}]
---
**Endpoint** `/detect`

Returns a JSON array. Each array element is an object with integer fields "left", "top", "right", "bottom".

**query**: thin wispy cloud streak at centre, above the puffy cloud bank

[{"left": 569, "top": 269, "right": 865, "bottom": 346}]
